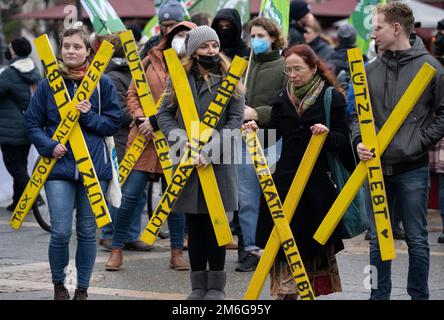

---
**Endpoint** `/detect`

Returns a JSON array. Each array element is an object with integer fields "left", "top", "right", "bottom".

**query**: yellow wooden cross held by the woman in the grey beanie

[{"left": 141, "top": 50, "right": 247, "bottom": 246}]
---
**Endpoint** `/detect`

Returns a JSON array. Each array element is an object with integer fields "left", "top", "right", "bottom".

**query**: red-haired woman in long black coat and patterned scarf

[{"left": 243, "top": 44, "right": 349, "bottom": 300}]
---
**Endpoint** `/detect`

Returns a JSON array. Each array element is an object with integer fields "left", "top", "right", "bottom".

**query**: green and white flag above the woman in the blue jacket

[{"left": 80, "top": 0, "right": 126, "bottom": 35}]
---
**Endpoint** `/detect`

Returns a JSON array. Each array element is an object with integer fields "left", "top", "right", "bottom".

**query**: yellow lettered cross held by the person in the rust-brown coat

[{"left": 119, "top": 30, "right": 173, "bottom": 186}]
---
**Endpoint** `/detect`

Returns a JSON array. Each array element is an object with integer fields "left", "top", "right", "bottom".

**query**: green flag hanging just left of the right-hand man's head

[{"left": 349, "top": 0, "right": 387, "bottom": 54}]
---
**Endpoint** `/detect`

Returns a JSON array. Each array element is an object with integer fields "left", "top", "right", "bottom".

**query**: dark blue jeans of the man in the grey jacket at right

[{"left": 366, "top": 165, "right": 430, "bottom": 300}]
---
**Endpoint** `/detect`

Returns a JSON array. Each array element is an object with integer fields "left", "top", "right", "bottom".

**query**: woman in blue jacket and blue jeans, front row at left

[{"left": 26, "top": 22, "right": 121, "bottom": 300}]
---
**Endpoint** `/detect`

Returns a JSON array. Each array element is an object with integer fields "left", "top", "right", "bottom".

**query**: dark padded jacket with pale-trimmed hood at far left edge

[{"left": 0, "top": 58, "right": 40, "bottom": 145}]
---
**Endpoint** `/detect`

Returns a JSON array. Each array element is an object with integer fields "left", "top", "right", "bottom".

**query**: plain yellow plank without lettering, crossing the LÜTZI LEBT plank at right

[{"left": 313, "top": 63, "right": 436, "bottom": 244}]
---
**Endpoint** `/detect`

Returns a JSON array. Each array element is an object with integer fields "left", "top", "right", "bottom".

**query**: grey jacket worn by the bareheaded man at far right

[{"left": 352, "top": 37, "right": 444, "bottom": 174}]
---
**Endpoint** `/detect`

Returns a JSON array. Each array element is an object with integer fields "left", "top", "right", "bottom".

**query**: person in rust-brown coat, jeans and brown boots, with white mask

[{"left": 105, "top": 21, "right": 196, "bottom": 271}]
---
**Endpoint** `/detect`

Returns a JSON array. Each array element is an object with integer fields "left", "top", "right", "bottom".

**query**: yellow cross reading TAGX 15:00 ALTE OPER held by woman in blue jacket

[{"left": 9, "top": 35, "right": 114, "bottom": 229}]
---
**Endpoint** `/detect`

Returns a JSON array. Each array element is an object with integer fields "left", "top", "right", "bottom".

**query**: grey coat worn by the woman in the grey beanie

[{"left": 156, "top": 71, "right": 245, "bottom": 213}]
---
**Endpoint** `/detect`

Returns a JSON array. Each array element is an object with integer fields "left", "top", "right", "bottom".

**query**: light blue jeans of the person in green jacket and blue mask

[{"left": 236, "top": 140, "right": 282, "bottom": 251}]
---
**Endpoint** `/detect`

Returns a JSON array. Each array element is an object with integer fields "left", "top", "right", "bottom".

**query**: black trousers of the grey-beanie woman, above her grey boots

[{"left": 186, "top": 213, "right": 226, "bottom": 271}]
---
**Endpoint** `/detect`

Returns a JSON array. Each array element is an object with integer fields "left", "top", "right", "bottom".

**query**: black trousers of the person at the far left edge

[{"left": 1, "top": 144, "right": 31, "bottom": 204}]
